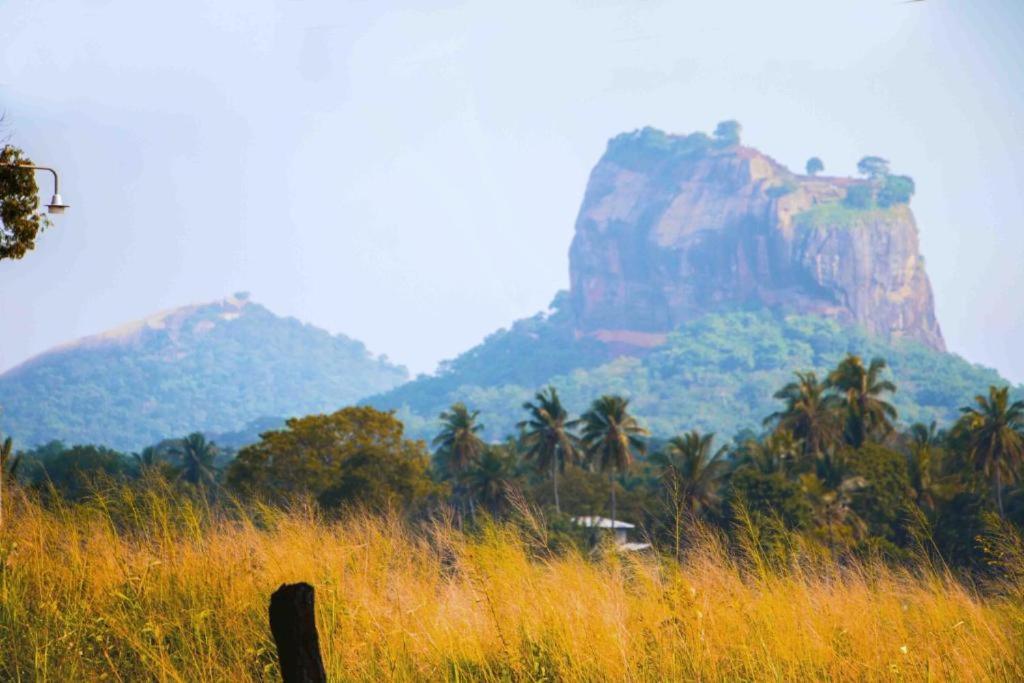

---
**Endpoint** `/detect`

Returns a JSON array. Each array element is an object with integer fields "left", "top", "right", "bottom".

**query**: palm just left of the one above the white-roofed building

[{"left": 518, "top": 387, "right": 582, "bottom": 513}]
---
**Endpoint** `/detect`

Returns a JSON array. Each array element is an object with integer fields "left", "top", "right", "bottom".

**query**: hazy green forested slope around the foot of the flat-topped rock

[{"left": 366, "top": 301, "right": 1021, "bottom": 438}]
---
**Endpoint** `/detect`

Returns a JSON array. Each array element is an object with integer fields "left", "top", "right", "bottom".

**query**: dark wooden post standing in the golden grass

[{"left": 270, "top": 584, "right": 327, "bottom": 683}]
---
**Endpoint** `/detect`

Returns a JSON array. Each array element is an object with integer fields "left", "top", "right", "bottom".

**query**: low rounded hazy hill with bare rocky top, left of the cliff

[{"left": 0, "top": 295, "right": 408, "bottom": 450}]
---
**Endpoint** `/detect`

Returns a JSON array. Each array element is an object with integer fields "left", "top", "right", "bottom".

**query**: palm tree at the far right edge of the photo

[{"left": 961, "top": 386, "right": 1024, "bottom": 517}]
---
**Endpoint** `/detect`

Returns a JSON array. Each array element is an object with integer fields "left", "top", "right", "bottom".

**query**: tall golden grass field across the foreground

[{"left": 0, "top": 489, "right": 1024, "bottom": 682}]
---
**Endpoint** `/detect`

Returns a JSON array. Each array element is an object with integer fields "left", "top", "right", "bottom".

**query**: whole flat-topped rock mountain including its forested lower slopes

[{"left": 368, "top": 128, "right": 1019, "bottom": 438}]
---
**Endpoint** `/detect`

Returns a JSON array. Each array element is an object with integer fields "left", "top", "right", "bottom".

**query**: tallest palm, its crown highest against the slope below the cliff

[{"left": 828, "top": 353, "right": 896, "bottom": 449}]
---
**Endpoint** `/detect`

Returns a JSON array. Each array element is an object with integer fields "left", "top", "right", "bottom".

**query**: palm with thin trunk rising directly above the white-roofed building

[{"left": 581, "top": 395, "right": 647, "bottom": 530}]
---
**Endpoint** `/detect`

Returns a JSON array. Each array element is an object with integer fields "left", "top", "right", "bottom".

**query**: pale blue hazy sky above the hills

[{"left": 0, "top": 0, "right": 1024, "bottom": 381}]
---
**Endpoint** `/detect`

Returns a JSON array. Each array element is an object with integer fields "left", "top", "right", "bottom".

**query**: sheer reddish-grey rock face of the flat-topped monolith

[{"left": 569, "top": 129, "right": 945, "bottom": 349}]
